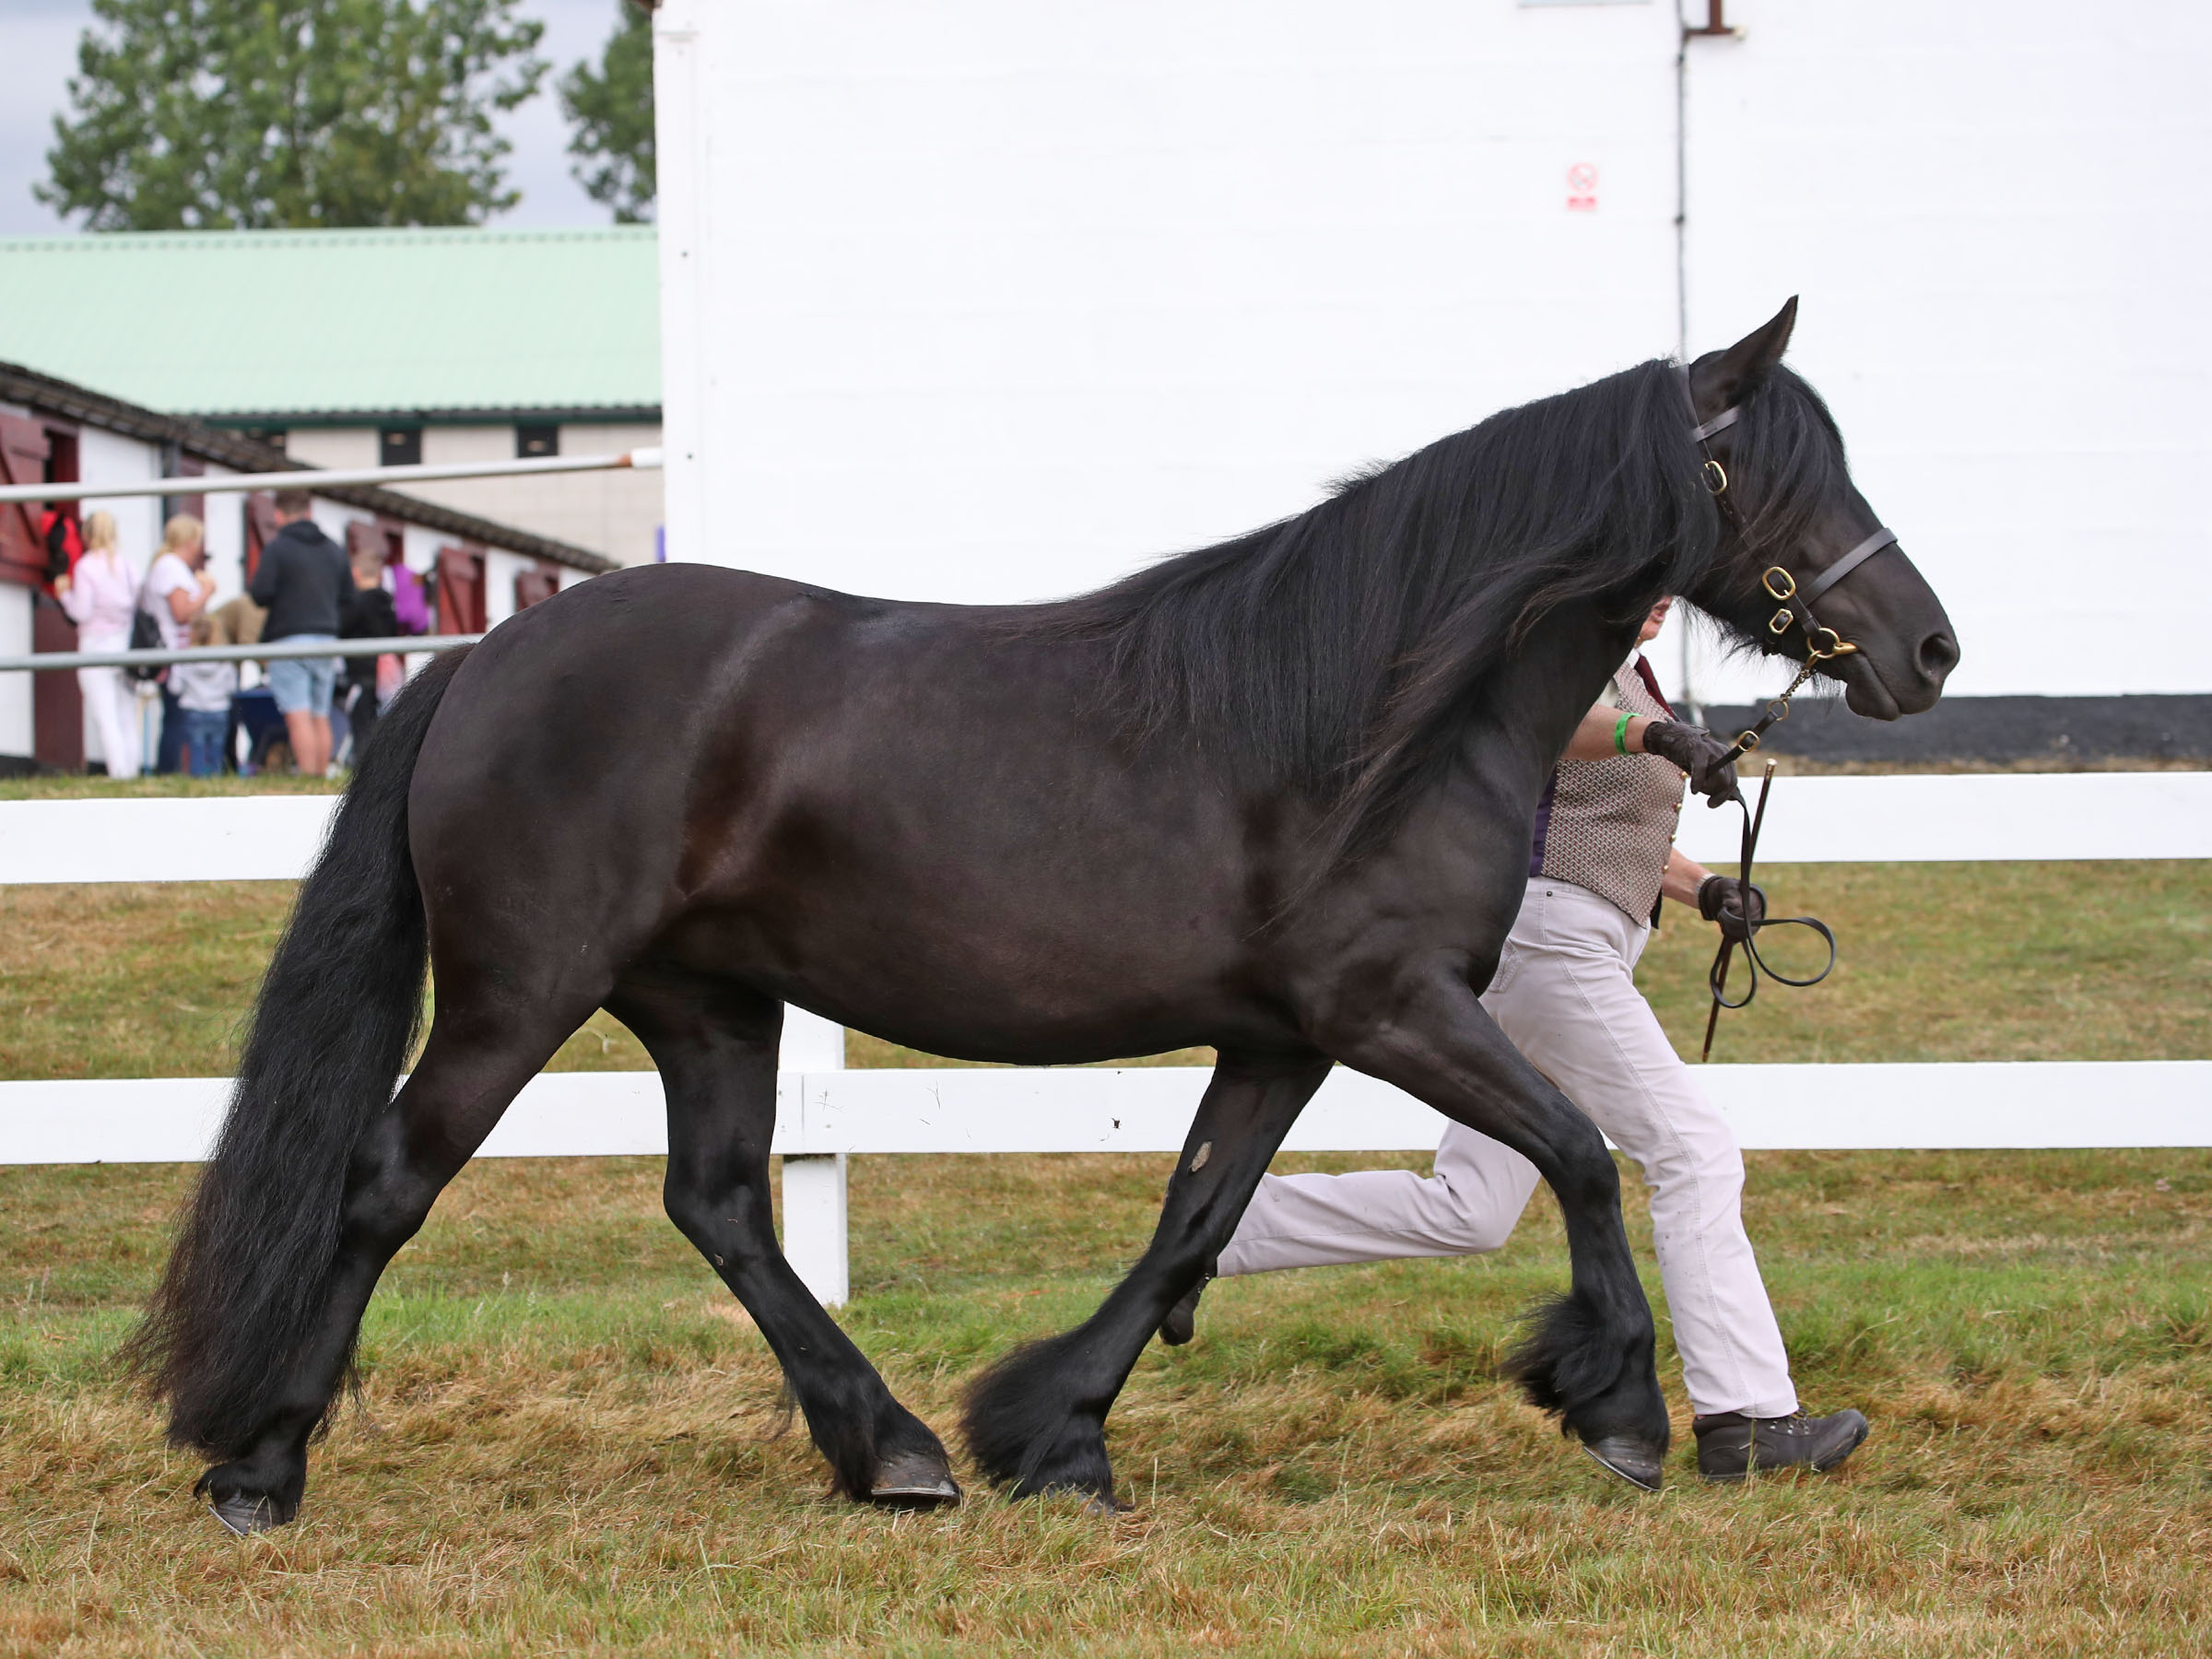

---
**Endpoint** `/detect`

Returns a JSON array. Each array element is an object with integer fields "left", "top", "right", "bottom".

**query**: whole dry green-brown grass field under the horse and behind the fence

[{"left": 0, "top": 787, "right": 2212, "bottom": 1659}]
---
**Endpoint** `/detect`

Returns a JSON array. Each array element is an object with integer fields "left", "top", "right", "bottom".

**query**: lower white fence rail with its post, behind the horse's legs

[{"left": 0, "top": 1065, "right": 2212, "bottom": 1305}]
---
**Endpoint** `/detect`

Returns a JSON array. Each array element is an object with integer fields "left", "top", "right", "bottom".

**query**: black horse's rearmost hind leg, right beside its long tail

[{"left": 194, "top": 1002, "right": 591, "bottom": 1533}]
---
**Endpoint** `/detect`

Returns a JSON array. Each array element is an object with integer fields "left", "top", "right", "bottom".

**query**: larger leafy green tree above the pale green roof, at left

[{"left": 33, "top": 0, "right": 547, "bottom": 230}]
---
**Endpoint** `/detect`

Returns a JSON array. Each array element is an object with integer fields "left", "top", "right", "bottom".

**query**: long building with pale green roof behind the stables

[{"left": 0, "top": 226, "right": 662, "bottom": 564}]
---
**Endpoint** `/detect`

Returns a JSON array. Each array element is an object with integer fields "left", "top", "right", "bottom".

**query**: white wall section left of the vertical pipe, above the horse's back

[{"left": 654, "top": 0, "right": 1675, "bottom": 599}]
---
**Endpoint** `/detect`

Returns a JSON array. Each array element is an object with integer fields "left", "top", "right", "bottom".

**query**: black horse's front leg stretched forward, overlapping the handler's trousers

[{"left": 1323, "top": 967, "right": 1670, "bottom": 1488}]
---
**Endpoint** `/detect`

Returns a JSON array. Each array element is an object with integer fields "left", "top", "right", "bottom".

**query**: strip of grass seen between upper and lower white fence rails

[{"left": 0, "top": 861, "right": 2212, "bottom": 1077}]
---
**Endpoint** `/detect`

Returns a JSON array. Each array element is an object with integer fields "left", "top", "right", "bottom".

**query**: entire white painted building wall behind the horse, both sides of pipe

[{"left": 654, "top": 0, "right": 2212, "bottom": 701}]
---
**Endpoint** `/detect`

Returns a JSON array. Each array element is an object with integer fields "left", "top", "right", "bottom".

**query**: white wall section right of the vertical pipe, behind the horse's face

[{"left": 1688, "top": 0, "right": 2212, "bottom": 695}]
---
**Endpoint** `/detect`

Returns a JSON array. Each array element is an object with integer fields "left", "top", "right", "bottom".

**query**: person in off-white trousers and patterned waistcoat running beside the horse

[{"left": 1161, "top": 599, "right": 1867, "bottom": 1488}]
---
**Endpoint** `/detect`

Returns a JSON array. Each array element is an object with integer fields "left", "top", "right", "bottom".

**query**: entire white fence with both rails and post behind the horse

[{"left": 0, "top": 772, "right": 2212, "bottom": 1305}]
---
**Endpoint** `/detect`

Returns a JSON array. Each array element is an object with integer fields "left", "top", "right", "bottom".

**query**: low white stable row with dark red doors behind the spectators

[{"left": 0, "top": 363, "right": 618, "bottom": 772}]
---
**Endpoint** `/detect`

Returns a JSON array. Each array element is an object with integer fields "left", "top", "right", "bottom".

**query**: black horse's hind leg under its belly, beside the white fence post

[{"left": 608, "top": 973, "right": 960, "bottom": 1506}]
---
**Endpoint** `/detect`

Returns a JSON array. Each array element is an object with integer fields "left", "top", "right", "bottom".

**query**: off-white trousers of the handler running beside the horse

[{"left": 1218, "top": 878, "right": 1796, "bottom": 1418}]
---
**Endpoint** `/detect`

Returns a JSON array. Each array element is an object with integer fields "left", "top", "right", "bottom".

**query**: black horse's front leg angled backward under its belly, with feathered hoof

[{"left": 964, "top": 1055, "right": 1329, "bottom": 1509}]
